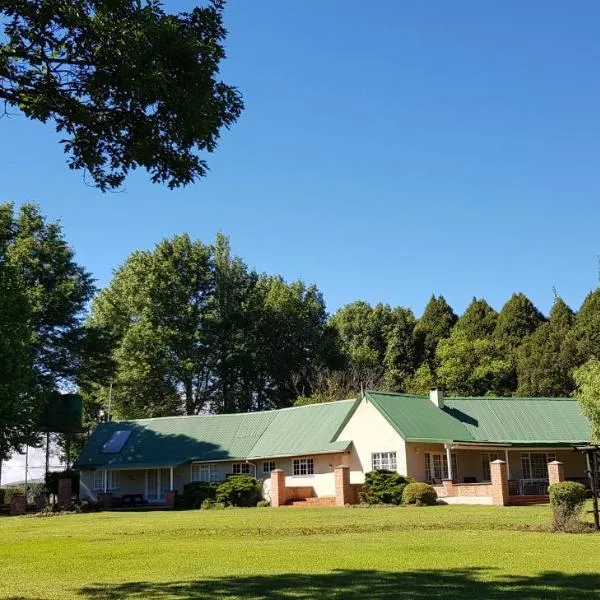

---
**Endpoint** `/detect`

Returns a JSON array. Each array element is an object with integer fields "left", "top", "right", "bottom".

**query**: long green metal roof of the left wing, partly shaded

[{"left": 75, "top": 400, "right": 355, "bottom": 469}]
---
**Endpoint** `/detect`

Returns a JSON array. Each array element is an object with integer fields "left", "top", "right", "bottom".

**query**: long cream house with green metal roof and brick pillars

[{"left": 75, "top": 390, "right": 591, "bottom": 505}]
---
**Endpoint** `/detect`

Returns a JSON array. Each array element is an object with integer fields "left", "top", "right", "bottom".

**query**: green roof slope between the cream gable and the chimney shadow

[{"left": 365, "top": 390, "right": 475, "bottom": 442}]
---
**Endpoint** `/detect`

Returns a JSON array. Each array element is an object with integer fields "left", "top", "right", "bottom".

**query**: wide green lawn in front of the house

[{"left": 0, "top": 506, "right": 600, "bottom": 600}]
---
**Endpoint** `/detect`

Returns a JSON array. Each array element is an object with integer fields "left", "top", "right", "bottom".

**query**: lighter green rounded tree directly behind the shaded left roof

[{"left": 89, "top": 235, "right": 215, "bottom": 417}]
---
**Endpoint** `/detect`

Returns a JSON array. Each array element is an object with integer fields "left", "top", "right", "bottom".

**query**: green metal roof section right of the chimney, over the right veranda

[{"left": 444, "top": 397, "right": 591, "bottom": 445}]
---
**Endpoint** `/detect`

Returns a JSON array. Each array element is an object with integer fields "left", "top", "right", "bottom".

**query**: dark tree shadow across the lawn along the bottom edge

[{"left": 75, "top": 569, "right": 600, "bottom": 600}]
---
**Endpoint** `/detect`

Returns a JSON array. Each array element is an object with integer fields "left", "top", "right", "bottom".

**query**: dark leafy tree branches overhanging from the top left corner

[{"left": 0, "top": 0, "right": 243, "bottom": 191}]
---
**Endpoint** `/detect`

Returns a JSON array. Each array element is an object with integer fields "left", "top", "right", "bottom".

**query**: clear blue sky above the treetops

[{"left": 0, "top": 0, "right": 600, "bottom": 314}]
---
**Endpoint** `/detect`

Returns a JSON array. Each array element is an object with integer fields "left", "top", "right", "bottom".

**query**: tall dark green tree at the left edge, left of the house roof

[{"left": 0, "top": 204, "right": 94, "bottom": 455}]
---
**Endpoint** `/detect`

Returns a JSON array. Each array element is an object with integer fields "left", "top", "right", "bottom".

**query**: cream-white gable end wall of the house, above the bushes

[{"left": 337, "top": 398, "right": 407, "bottom": 483}]
